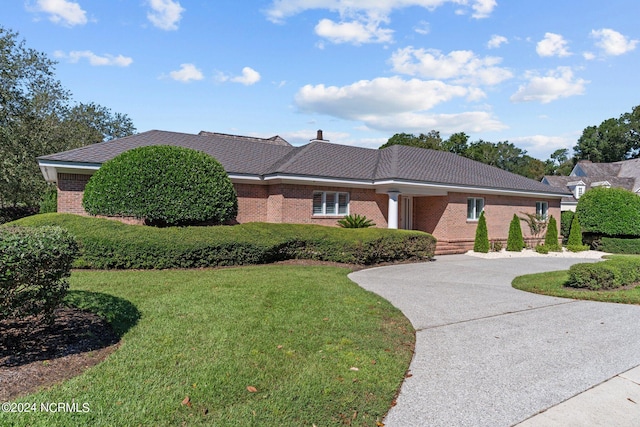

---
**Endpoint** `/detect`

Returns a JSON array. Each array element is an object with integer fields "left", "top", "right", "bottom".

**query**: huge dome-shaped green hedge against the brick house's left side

[{"left": 82, "top": 145, "right": 238, "bottom": 225}]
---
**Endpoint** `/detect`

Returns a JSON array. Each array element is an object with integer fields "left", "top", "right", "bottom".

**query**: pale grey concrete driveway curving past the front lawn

[{"left": 349, "top": 255, "right": 640, "bottom": 427}]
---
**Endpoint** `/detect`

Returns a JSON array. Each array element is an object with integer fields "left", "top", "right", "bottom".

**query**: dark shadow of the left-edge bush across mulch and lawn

[{"left": 0, "top": 291, "right": 140, "bottom": 368}]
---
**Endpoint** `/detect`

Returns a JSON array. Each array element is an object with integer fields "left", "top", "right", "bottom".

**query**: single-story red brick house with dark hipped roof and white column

[{"left": 38, "top": 130, "right": 568, "bottom": 254}]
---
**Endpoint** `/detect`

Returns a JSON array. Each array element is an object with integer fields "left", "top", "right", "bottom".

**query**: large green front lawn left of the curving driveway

[{"left": 0, "top": 265, "right": 415, "bottom": 426}]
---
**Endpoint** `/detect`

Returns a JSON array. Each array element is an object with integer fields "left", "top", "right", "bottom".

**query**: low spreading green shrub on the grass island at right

[{"left": 567, "top": 258, "right": 640, "bottom": 291}]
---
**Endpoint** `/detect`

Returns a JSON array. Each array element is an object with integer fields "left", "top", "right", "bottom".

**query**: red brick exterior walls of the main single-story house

[{"left": 58, "top": 173, "right": 560, "bottom": 246}]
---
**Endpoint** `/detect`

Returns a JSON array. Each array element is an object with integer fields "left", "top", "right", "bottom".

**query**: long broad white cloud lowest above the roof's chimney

[{"left": 295, "top": 77, "right": 504, "bottom": 133}]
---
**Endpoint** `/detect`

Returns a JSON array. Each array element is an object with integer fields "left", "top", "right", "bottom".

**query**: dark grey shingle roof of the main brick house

[{"left": 39, "top": 130, "right": 567, "bottom": 195}]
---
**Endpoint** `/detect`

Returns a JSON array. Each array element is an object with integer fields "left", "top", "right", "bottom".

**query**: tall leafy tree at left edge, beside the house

[{"left": 0, "top": 26, "right": 135, "bottom": 207}]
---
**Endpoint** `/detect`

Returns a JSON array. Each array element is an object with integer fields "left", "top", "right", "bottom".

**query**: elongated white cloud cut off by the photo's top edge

[{"left": 266, "top": 0, "right": 497, "bottom": 23}]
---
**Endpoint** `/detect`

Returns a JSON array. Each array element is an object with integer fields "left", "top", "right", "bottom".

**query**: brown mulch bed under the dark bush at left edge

[{"left": 0, "top": 307, "right": 119, "bottom": 402}]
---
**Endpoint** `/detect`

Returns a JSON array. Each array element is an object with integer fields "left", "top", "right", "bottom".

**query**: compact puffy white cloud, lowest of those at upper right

[{"left": 510, "top": 67, "right": 589, "bottom": 104}]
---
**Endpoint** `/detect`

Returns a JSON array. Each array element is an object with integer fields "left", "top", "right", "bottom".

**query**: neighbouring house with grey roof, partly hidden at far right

[{"left": 542, "top": 159, "right": 640, "bottom": 212}]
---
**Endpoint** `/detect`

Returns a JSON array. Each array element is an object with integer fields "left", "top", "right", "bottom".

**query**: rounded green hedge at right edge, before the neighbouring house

[{"left": 576, "top": 187, "right": 640, "bottom": 236}]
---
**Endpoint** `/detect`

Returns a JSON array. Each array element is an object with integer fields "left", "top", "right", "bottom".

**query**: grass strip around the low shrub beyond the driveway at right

[{"left": 512, "top": 255, "right": 640, "bottom": 304}]
